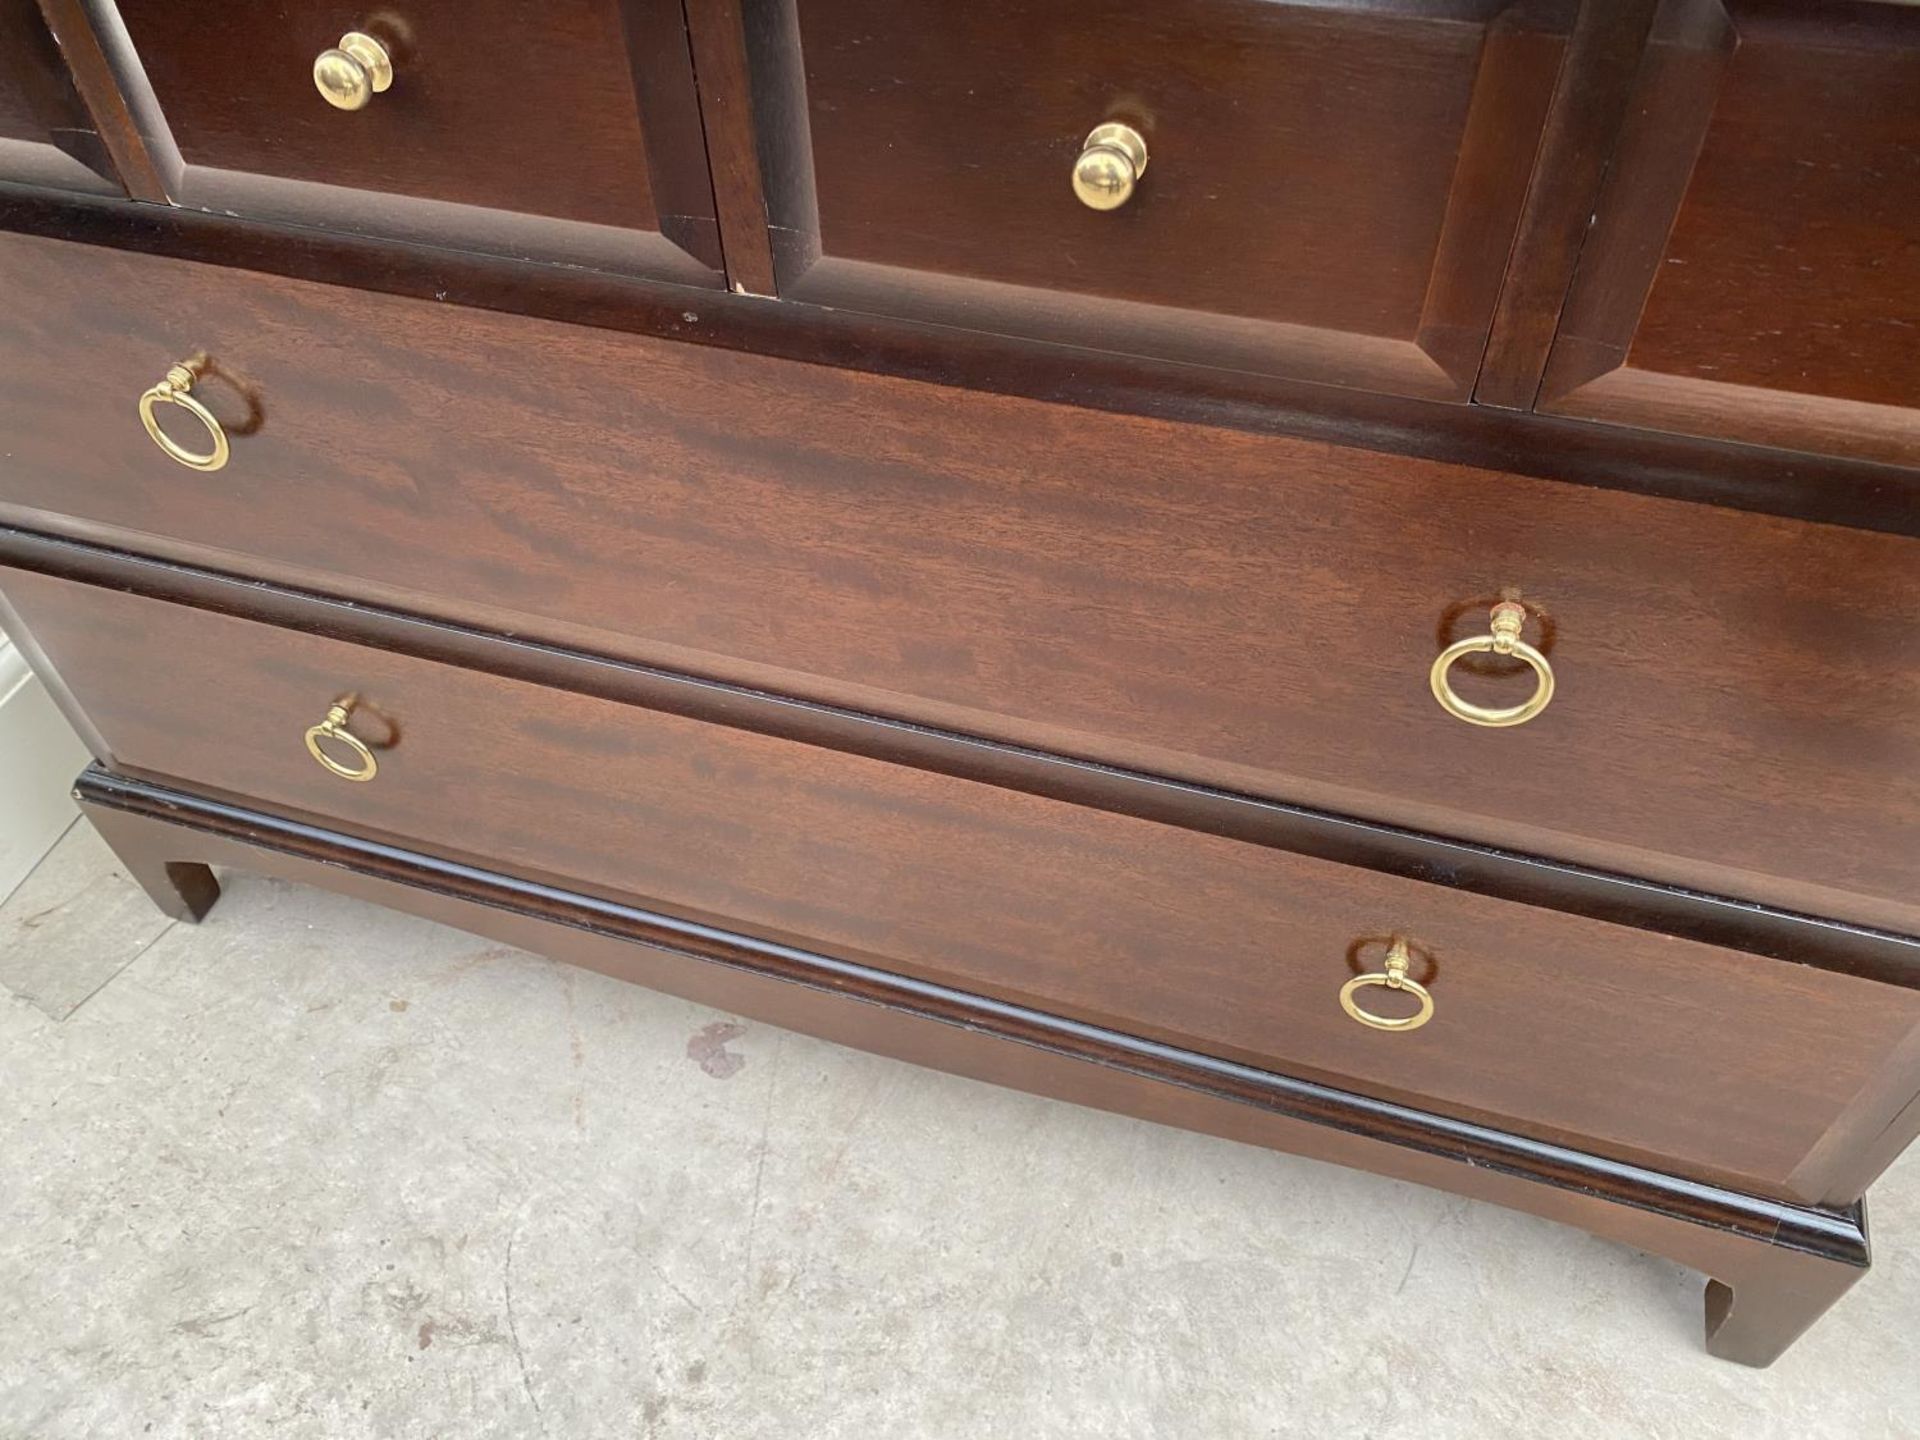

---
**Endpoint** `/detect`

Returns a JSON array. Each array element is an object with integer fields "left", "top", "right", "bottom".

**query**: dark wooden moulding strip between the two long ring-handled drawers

[{"left": 15, "top": 528, "right": 1920, "bottom": 987}]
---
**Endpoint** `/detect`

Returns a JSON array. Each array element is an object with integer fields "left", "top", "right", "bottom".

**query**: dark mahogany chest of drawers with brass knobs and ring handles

[{"left": 0, "top": 0, "right": 1920, "bottom": 1363}]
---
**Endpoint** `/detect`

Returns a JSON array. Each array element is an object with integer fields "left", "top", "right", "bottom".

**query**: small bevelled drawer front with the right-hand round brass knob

[{"left": 749, "top": 0, "right": 1572, "bottom": 399}]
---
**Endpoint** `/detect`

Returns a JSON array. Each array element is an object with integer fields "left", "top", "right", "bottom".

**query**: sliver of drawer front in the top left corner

[{"left": 0, "top": 0, "right": 121, "bottom": 196}]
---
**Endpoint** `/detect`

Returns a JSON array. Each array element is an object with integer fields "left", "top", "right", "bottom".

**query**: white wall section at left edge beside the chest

[{"left": 0, "top": 636, "right": 88, "bottom": 900}]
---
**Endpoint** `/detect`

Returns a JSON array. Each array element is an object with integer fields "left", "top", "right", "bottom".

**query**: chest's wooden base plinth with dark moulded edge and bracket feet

[{"left": 77, "top": 768, "right": 1870, "bottom": 1365}]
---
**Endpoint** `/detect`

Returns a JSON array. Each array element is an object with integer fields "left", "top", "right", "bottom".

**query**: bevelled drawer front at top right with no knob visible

[{"left": 1542, "top": 0, "right": 1920, "bottom": 465}]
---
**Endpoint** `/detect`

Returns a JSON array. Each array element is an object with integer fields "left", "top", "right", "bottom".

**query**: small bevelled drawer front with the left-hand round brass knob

[{"left": 119, "top": 0, "right": 718, "bottom": 284}]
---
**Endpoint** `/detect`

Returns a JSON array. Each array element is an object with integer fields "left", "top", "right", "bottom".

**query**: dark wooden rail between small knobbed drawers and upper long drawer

[{"left": 15, "top": 182, "right": 1920, "bottom": 536}]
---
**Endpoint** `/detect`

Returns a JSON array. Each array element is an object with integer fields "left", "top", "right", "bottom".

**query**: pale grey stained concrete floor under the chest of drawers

[{"left": 0, "top": 826, "right": 1920, "bottom": 1440}]
